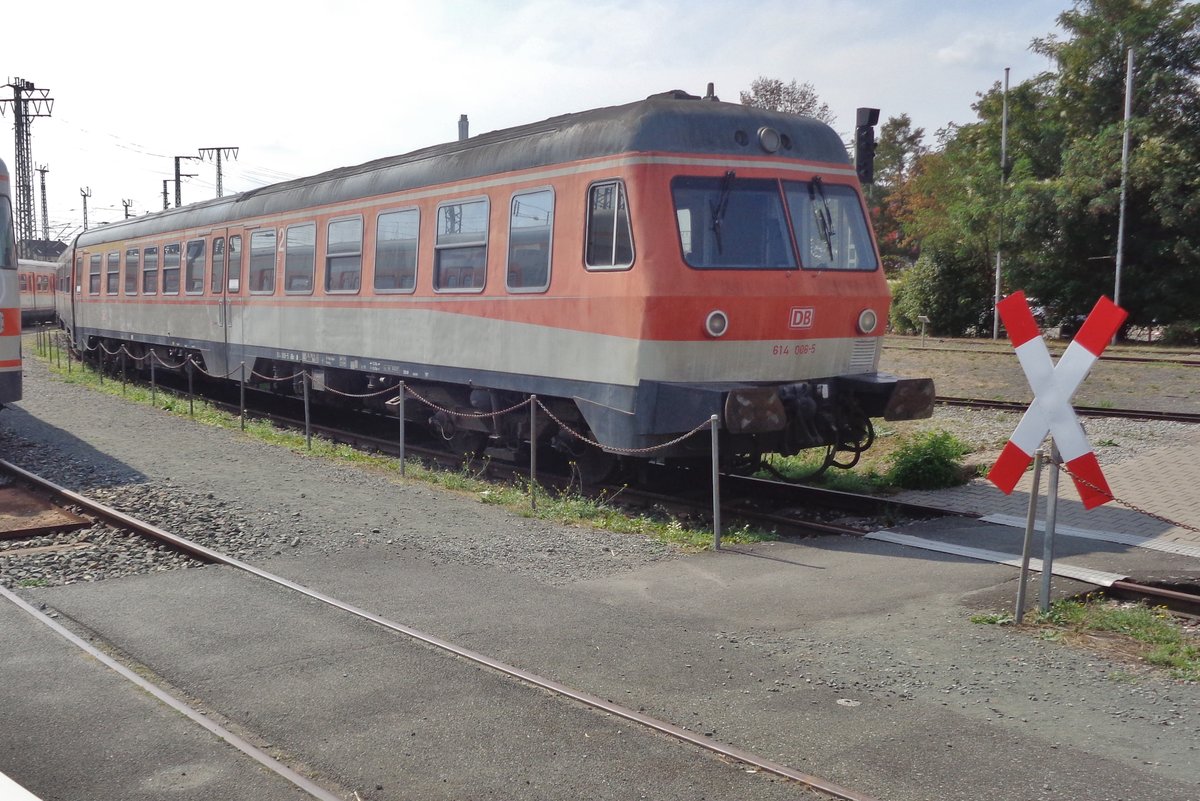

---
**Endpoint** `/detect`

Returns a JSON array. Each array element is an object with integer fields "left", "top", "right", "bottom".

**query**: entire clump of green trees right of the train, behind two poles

[{"left": 892, "top": 0, "right": 1200, "bottom": 335}]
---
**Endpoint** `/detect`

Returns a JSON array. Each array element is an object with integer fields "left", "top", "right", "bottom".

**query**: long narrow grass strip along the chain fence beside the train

[{"left": 26, "top": 343, "right": 778, "bottom": 550}]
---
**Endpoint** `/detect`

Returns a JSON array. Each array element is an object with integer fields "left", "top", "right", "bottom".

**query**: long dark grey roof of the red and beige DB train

[{"left": 76, "top": 90, "right": 850, "bottom": 247}]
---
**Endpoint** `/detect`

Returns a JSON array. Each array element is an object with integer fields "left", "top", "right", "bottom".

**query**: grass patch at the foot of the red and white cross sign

[{"left": 971, "top": 595, "right": 1200, "bottom": 681}]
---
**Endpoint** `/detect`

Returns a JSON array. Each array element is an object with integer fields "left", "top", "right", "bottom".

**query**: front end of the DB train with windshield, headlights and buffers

[{"left": 584, "top": 153, "right": 935, "bottom": 465}]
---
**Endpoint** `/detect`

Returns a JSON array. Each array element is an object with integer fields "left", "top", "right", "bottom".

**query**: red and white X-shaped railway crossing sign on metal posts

[{"left": 988, "top": 291, "right": 1128, "bottom": 508}]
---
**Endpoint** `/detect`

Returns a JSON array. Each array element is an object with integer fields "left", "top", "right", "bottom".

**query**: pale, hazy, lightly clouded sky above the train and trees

[{"left": 0, "top": 0, "right": 1070, "bottom": 239}]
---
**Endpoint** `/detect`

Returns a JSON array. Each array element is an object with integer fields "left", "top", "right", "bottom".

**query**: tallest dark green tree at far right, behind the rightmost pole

[{"left": 1012, "top": 0, "right": 1200, "bottom": 325}]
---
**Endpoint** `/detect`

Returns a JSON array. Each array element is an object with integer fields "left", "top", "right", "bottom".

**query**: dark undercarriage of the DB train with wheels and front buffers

[{"left": 79, "top": 338, "right": 934, "bottom": 483}]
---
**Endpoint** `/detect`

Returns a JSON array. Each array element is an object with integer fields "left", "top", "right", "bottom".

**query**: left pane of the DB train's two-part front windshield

[{"left": 671, "top": 170, "right": 796, "bottom": 270}]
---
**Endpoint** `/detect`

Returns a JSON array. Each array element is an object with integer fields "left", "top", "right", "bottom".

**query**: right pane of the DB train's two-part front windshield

[{"left": 784, "top": 177, "right": 878, "bottom": 271}]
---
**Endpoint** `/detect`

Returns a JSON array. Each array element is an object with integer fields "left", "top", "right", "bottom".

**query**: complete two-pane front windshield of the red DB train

[{"left": 671, "top": 170, "right": 878, "bottom": 270}]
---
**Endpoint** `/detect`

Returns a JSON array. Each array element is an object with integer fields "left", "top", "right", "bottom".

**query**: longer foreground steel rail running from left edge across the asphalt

[{"left": 0, "top": 459, "right": 876, "bottom": 801}]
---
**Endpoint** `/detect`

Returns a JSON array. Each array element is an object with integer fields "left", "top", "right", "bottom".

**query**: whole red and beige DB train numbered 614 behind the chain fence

[{"left": 60, "top": 91, "right": 934, "bottom": 469}]
